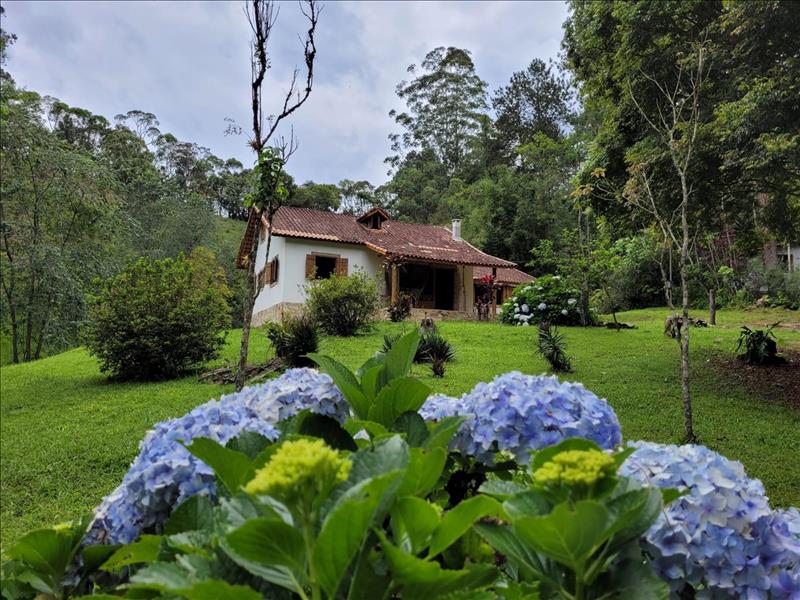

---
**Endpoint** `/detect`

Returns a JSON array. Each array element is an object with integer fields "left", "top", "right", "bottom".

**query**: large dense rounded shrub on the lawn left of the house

[{"left": 87, "top": 248, "right": 230, "bottom": 380}]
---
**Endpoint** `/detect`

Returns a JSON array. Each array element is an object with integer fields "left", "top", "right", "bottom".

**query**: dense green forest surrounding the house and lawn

[{"left": 0, "top": 0, "right": 800, "bottom": 362}]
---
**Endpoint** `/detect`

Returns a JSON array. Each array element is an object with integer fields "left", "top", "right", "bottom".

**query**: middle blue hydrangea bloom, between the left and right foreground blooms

[{"left": 420, "top": 371, "right": 622, "bottom": 464}]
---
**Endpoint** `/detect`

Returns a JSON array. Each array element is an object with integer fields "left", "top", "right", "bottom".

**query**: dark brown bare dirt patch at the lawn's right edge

[{"left": 711, "top": 350, "right": 800, "bottom": 409}]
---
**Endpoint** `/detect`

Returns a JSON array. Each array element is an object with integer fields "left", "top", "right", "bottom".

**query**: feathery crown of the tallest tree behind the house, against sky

[{"left": 386, "top": 46, "right": 487, "bottom": 175}]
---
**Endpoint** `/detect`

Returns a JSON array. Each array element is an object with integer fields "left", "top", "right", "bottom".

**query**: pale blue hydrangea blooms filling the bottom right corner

[{"left": 620, "top": 442, "right": 800, "bottom": 600}]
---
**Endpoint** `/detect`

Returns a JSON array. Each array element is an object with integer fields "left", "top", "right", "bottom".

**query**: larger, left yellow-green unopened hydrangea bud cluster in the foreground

[{"left": 244, "top": 440, "right": 352, "bottom": 499}]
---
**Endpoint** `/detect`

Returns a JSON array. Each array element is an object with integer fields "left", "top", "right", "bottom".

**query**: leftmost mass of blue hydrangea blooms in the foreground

[{"left": 86, "top": 369, "right": 348, "bottom": 544}]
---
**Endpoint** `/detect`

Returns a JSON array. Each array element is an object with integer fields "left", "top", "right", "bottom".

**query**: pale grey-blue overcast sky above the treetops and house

[{"left": 3, "top": 1, "right": 567, "bottom": 184}]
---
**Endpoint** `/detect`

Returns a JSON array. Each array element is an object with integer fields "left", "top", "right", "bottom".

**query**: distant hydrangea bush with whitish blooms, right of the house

[{"left": 500, "top": 275, "right": 581, "bottom": 326}]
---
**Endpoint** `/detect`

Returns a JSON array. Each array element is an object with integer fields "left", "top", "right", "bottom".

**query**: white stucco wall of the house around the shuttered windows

[{"left": 253, "top": 236, "right": 384, "bottom": 315}]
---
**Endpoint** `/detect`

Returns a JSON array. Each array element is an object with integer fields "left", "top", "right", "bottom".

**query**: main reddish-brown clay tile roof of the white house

[{"left": 238, "top": 206, "right": 516, "bottom": 268}]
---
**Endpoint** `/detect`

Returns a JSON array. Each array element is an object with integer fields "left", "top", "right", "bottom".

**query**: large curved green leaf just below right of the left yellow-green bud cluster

[{"left": 311, "top": 471, "right": 402, "bottom": 597}]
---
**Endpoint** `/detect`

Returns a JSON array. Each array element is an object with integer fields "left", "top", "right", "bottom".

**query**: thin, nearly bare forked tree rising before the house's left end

[{"left": 236, "top": 0, "right": 319, "bottom": 390}]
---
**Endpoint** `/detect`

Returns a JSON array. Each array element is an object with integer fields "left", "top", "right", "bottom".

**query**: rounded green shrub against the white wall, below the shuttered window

[{"left": 306, "top": 271, "right": 379, "bottom": 336}]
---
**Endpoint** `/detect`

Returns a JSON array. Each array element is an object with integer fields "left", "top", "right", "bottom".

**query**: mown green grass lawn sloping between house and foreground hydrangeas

[{"left": 0, "top": 309, "right": 800, "bottom": 545}]
